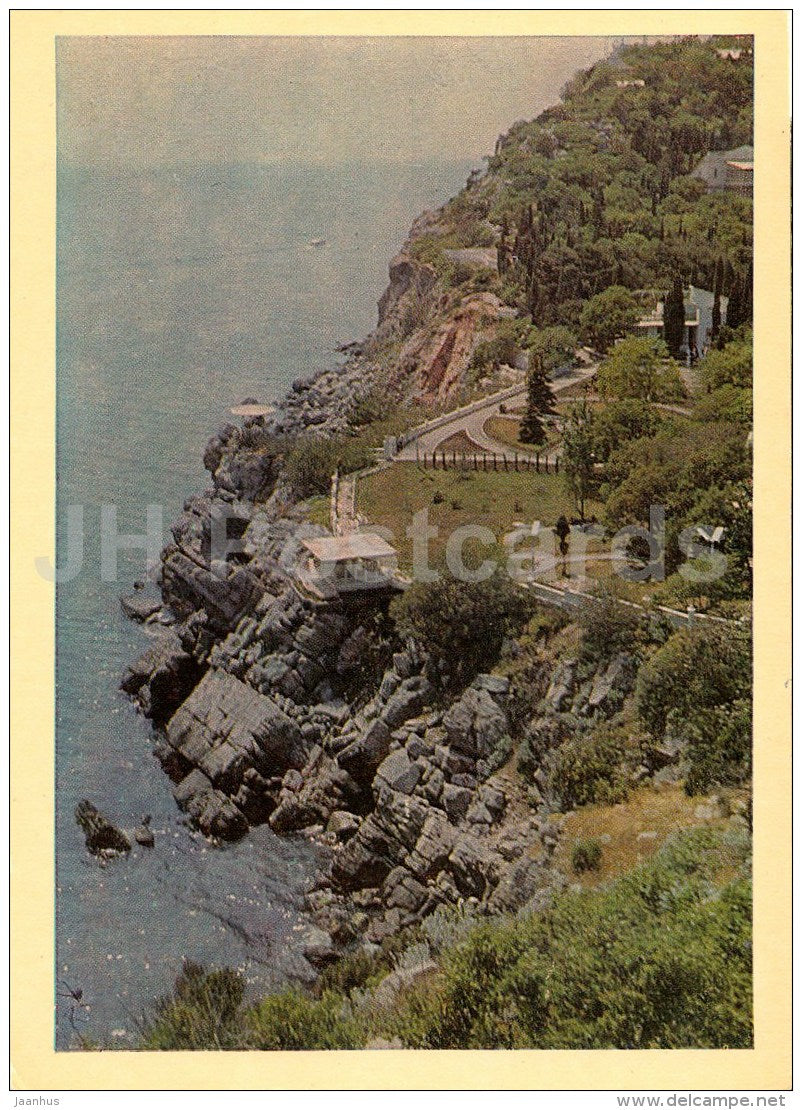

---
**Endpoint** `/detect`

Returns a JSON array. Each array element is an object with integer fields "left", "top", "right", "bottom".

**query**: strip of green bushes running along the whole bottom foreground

[{"left": 142, "top": 828, "right": 752, "bottom": 1050}]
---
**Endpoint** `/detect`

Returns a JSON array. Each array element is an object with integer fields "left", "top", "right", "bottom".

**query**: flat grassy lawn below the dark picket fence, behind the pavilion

[{"left": 357, "top": 463, "right": 601, "bottom": 569}]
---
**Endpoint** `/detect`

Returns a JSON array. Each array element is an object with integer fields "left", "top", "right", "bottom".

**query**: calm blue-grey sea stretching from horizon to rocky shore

[{"left": 55, "top": 164, "right": 470, "bottom": 1048}]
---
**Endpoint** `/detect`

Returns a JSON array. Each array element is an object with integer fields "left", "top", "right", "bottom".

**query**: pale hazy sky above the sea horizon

[{"left": 57, "top": 37, "right": 611, "bottom": 165}]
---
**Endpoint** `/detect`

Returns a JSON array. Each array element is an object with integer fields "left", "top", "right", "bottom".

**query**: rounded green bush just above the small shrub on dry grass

[{"left": 549, "top": 725, "right": 632, "bottom": 810}]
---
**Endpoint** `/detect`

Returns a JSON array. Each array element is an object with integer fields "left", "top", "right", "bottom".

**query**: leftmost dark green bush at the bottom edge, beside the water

[{"left": 143, "top": 960, "right": 244, "bottom": 1051}]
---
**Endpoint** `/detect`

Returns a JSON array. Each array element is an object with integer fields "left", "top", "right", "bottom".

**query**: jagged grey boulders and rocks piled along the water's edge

[{"left": 104, "top": 231, "right": 631, "bottom": 969}]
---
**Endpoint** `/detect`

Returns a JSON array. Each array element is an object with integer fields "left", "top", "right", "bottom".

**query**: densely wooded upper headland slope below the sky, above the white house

[{"left": 416, "top": 39, "right": 752, "bottom": 337}]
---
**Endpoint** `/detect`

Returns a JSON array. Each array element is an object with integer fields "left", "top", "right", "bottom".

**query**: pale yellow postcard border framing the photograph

[{"left": 10, "top": 10, "right": 791, "bottom": 1090}]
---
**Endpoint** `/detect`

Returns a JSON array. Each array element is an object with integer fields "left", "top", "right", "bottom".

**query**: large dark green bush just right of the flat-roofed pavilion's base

[{"left": 390, "top": 574, "right": 532, "bottom": 684}]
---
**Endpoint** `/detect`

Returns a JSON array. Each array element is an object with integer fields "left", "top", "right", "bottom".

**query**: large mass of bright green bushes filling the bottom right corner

[{"left": 388, "top": 830, "right": 752, "bottom": 1049}]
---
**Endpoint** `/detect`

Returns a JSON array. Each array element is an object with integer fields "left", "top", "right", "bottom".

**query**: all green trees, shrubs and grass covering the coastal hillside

[{"left": 136, "top": 39, "right": 753, "bottom": 1050}]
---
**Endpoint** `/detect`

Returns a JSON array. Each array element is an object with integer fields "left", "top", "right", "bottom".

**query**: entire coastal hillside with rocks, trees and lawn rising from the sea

[{"left": 109, "top": 40, "right": 752, "bottom": 1049}]
